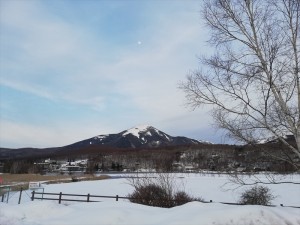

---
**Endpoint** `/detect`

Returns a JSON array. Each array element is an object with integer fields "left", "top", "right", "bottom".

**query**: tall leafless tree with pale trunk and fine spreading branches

[{"left": 180, "top": 0, "right": 300, "bottom": 169}]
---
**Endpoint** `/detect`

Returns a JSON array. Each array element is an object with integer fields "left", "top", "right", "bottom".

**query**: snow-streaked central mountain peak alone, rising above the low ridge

[{"left": 65, "top": 125, "right": 202, "bottom": 149}]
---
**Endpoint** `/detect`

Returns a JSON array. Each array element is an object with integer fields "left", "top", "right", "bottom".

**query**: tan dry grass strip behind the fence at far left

[{"left": 0, "top": 173, "right": 109, "bottom": 190}]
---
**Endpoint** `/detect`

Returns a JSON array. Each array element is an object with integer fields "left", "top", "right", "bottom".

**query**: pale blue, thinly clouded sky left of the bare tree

[{"left": 0, "top": 0, "right": 224, "bottom": 148}]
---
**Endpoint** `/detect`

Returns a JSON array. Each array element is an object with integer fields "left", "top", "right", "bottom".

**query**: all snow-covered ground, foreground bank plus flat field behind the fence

[{"left": 0, "top": 174, "right": 300, "bottom": 225}]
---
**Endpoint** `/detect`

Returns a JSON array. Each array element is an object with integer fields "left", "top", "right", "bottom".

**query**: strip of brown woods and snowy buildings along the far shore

[{"left": 4, "top": 149, "right": 292, "bottom": 174}]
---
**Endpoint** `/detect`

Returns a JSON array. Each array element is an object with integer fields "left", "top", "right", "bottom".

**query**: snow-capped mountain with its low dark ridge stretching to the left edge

[{"left": 0, "top": 125, "right": 207, "bottom": 161}]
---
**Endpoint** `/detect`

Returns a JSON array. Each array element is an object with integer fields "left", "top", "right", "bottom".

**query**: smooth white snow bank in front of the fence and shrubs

[{"left": 0, "top": 201, "right": 300, "bottom": 225}]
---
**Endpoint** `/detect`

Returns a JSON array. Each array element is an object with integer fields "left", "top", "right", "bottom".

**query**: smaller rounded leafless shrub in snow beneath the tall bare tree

[{"left": 239, "top": 186, "right": 275, "bottom": 205}]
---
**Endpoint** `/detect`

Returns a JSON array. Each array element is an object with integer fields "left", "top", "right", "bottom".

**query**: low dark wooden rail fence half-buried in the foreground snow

[{"left": 31, "top": 191, "right": 300, "bottom": 209}]
